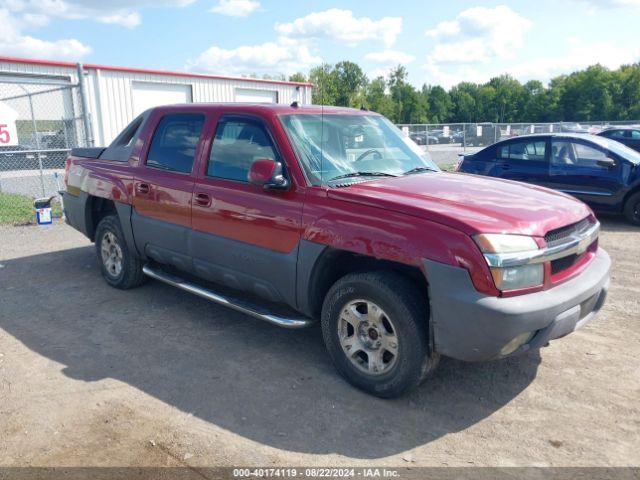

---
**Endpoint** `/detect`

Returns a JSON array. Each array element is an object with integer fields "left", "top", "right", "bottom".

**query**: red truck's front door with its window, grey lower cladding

[{"left": 191, "top": 115, "right": 304, "bottom": 305}]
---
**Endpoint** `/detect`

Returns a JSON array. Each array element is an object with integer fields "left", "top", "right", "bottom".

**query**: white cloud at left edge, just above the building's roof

[{"left": 0, "top": 9, "right": 91, "bottom": 60}]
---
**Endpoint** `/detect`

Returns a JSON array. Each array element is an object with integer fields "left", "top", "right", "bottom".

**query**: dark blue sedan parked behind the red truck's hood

[{"left": 458, "top": 133, "right": 640, "bottom": 225}]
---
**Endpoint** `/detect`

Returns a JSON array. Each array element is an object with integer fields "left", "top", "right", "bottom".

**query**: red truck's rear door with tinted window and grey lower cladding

[{"left": 131, "top": 111, "right": 205, "bottom": 271}]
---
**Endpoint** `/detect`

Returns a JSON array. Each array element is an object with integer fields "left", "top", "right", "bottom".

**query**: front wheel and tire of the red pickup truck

[{"left": 322, "top": 271, "right": 438, "bottom": 398}]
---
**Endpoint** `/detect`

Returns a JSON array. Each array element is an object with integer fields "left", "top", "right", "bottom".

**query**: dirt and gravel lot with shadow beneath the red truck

[{"left": 0, "top": 219, "right": 640, "bottom": 468}]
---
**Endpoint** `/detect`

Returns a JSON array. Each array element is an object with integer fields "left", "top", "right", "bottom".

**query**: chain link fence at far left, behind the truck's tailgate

[{"left": 0, "top": 76, "right": 88, "bottom": 225}]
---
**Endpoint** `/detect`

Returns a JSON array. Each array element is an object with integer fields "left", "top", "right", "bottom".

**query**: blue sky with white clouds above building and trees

[{"left": 0, "top": 0, "right": 640, "bottom": 88}]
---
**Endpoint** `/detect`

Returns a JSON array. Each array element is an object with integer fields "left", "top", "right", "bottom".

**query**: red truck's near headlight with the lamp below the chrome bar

[{"left": 473, "top": 233, "right": 544, "bottom": 291}]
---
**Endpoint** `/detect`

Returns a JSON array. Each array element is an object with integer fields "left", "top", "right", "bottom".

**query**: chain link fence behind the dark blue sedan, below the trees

[{"left": 398, "top": 121, "right": 640, "bottom": 169}]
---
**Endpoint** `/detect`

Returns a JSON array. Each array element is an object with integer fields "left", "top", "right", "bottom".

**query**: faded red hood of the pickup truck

[{"left": 328, "top": 172, "right": 591, "bottom": 236}]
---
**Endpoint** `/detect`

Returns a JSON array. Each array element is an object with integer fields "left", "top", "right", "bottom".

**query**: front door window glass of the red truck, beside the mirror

[{"left": 207, "top": 119, "right": 277, "bottom": 182}]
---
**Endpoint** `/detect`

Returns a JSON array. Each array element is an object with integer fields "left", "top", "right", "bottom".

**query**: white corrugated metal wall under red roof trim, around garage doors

[{"left": 0, "top": 61, "right": 311, "bottom": 145}]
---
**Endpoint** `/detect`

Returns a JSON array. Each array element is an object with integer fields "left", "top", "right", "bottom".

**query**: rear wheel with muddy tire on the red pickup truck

[{"left": 95, "top": 215, "right": 146, "bottom": 290}]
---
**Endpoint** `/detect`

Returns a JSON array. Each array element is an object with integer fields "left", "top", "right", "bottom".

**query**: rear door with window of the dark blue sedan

[{"left": 490, "top": 137, "right": 549, "bottom": 186}]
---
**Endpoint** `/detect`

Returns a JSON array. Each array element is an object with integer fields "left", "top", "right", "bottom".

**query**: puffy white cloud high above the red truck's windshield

[{"left": 276, "top": 8, "right": 402, "bottom": 47}]
